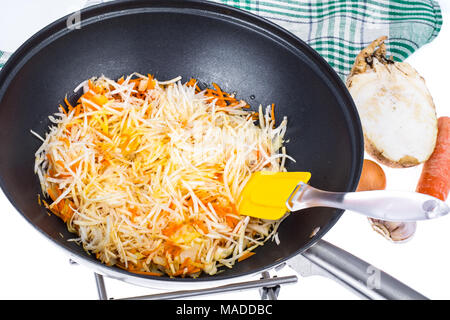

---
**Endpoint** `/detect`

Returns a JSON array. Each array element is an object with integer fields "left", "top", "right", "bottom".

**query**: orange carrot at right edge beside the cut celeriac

[{"left": 416, "top": 117, "right": 450, "bottom": 201}]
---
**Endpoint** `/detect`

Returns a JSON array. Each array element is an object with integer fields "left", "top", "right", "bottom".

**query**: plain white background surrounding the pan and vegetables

[{"left": 0, "top": 0, "right": 450, "bottom": 300}]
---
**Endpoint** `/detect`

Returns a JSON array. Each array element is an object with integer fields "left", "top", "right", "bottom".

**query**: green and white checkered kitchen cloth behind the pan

[{"left": 0, "top": 0, "right": 442, "bottom": 80}]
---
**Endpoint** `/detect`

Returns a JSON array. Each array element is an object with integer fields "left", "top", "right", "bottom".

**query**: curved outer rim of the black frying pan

[{"left": 0, "top": 0, "right": 364, "bottom": 285}]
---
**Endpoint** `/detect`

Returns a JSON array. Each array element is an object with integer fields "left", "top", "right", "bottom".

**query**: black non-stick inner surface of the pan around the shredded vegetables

[{"left": 0, "top": 1, "right": 363, "bottom": 281}]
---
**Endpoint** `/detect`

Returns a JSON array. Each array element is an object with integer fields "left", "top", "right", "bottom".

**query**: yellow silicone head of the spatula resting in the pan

[{"left": 238, "top": 171, "right": 311, "bottom": 220}]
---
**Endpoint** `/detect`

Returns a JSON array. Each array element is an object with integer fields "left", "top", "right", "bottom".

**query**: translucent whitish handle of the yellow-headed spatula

[{"left": 286, "top": 182, "right": 450, "bottom": 221}]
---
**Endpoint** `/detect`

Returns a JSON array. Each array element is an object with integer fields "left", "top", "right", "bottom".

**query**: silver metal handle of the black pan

[{"left": 288, "top": 240, "right": 428, "bottom": 300}]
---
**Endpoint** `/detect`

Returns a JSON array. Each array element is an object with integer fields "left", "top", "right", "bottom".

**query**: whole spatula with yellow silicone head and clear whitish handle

[{"left": 238, "top": 172, "right": 450, "bottom": 221}]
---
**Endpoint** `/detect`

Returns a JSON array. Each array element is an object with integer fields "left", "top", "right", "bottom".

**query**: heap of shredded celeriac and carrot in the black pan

[{"left": 32, "top": 73, "right": 290, "bottom": 277}]
